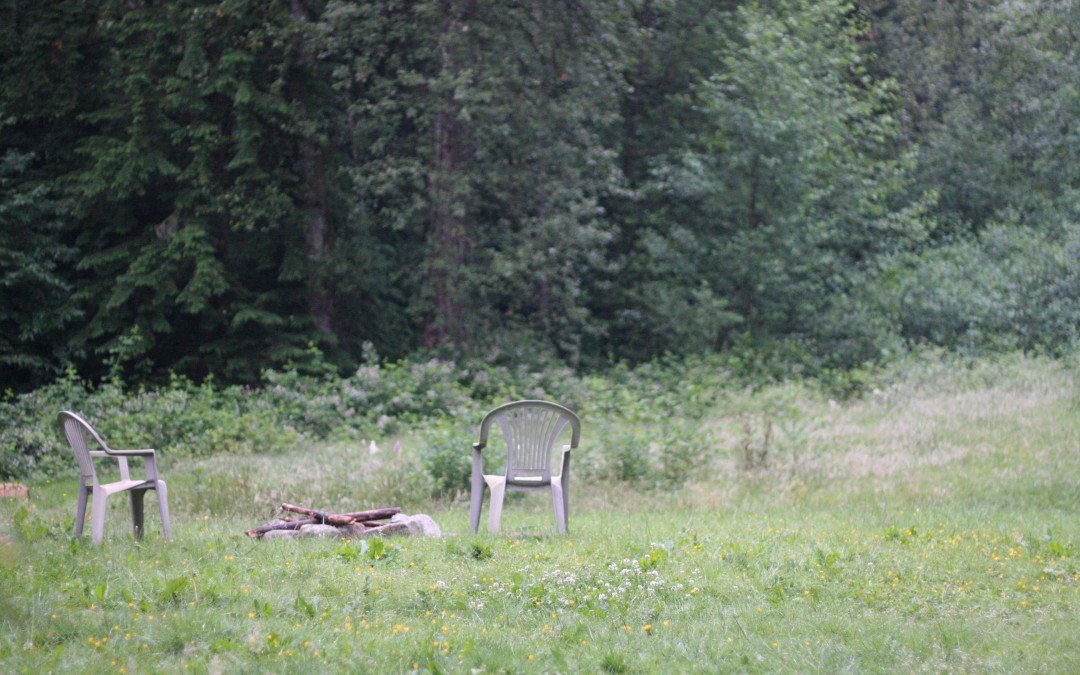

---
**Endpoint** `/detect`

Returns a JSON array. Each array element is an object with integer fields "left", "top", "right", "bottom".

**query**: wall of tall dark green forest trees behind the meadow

[{"left": 0, "top": 0, "right": 1080, "bottom": 390}]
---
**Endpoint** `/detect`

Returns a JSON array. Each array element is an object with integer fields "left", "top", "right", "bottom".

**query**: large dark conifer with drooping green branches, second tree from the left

[{"left": 64, "top": 1, "right": 341, "bottom": 380}]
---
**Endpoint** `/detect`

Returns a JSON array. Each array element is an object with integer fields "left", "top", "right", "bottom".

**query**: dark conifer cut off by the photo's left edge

[{"left": 0, "top": 0, "right": 104, "bottom": 390}]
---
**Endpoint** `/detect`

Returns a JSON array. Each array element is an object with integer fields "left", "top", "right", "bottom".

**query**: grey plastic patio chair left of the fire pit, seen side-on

[{"left": 58, "top": 410, "right": 172, "bottom": 543}]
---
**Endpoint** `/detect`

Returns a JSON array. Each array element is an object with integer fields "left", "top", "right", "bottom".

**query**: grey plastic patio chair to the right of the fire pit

[{"left": 469, "top": 401, "right": 581, "bottom": 535}]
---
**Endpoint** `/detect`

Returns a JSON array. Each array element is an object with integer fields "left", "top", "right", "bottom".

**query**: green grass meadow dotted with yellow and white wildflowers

[{"left": 0, "top": 357, "right": 1080, "bottom": 673}]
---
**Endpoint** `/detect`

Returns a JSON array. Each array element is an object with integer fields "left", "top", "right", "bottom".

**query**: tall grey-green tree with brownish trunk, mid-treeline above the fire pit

[{"left": 325, "top": 1, "right": 621, "bottom": 357}]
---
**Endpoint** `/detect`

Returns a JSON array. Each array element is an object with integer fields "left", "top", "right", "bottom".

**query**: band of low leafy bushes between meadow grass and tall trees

[{"left": 0, "top": 345, "right": 730, "bottom": 481}]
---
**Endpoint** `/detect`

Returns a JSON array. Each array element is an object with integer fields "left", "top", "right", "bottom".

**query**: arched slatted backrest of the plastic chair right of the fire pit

[{"left": 480, "top": 401, "right": 581, "bottom": 482}]
